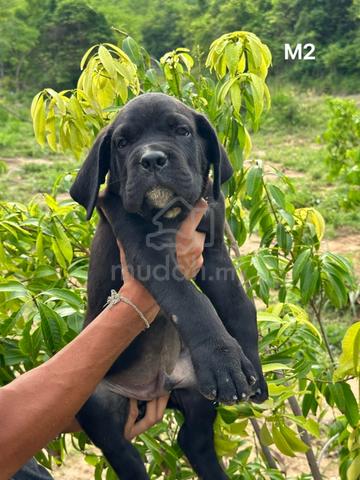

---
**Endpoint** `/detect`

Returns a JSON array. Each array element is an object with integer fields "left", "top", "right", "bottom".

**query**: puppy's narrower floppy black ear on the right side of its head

[{"left": 196, "top": 113, "right": 233, "bottom": 200}]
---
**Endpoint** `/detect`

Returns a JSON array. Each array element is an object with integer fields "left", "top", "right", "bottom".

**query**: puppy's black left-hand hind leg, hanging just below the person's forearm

[{"left": 76, "top": 383, "right": 149, "bottom": 480}]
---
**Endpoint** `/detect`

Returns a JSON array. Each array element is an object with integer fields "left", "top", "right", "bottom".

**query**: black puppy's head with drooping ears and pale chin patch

[{"left": 70, "top": 93, "right": 232, "bottom": 218}]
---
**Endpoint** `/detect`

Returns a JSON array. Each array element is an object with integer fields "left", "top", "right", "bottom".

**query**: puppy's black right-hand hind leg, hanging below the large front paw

[{"left": 168, "top": 390, "right": 229, "bottom": 480}]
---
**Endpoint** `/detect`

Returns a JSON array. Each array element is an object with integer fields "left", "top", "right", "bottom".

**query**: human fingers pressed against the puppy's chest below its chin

[{"left": 176, "top": 198, "right": 208, "bottom": 280}]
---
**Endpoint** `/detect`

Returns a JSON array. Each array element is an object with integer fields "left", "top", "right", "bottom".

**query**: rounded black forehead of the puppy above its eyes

[{"left": 114, "top": 93, "right": 195, "bottom": 130}]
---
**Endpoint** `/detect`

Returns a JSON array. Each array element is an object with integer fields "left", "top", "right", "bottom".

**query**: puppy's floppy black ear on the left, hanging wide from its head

[{"left": 70, "top": 127, "right": 112, "bottom": 220}]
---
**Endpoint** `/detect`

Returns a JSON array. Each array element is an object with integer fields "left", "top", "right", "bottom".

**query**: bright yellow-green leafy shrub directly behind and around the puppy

[{"left": 0, "top": 31, "right": 360, "bottom": 480}]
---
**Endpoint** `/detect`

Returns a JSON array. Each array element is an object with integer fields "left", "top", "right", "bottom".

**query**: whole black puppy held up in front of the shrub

[{"left": 71, "top": 93, "right": 267, "bottom": 480}]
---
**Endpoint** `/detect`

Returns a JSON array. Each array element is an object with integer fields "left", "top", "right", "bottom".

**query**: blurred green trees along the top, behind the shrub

[{"left": 0, "top": 0, "right": 360, "bottom": 93}]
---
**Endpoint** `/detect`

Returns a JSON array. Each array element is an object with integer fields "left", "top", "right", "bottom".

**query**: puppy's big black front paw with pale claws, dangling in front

[{"left": 193, "top": 337, "right": 257, "bottom": 405}]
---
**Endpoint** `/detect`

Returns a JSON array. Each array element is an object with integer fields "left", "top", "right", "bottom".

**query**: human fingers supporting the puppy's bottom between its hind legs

[{"left": 124, "top": 395, "right": 169, "bottom": 440}]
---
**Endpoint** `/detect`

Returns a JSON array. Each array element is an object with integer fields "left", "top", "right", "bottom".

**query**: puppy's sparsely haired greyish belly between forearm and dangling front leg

[{"left": 104, "top": 315, "right": 196, "bottom": 401}]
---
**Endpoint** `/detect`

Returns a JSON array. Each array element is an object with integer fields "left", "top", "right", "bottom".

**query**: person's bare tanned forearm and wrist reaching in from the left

[{"left": 0, "top": 286, "right": 158, "bottom": 480}]
